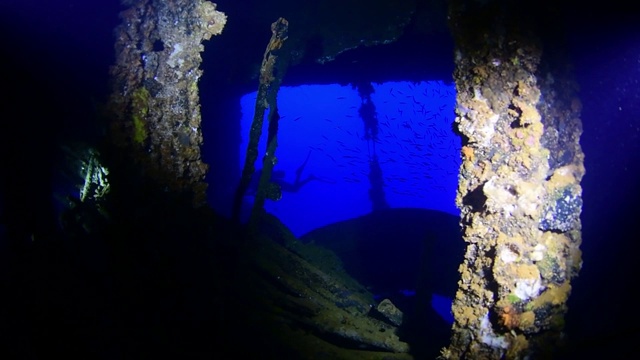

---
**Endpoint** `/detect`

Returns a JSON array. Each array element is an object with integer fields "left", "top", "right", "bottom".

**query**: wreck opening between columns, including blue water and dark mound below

[{"left": 203, "top": 16, "right": 464, "bottom": 357}]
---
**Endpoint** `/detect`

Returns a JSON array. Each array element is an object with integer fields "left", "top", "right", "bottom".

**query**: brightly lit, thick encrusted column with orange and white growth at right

[{"left": 441, "top": 1, "right": 584, "bottom": 359}]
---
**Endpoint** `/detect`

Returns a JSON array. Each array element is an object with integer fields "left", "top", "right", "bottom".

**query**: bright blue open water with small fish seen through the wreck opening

[{"left": 232, "top": 81, "right": 460, "bottom": 236}]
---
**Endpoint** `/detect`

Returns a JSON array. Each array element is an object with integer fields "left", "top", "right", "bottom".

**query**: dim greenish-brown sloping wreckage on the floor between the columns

[{"left": 234, "top": 214, "right": 413, "bottom": 360}]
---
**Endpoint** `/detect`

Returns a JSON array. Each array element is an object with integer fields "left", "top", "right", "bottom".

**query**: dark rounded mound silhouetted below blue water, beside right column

[{"left": 300, "top": 209, "right": 464, "bottom": 359}]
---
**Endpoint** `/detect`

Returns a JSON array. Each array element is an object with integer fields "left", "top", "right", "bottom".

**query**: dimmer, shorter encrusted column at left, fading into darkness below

[{"left": 105, "top": 0, "right": 226, "bottom": 205}]
